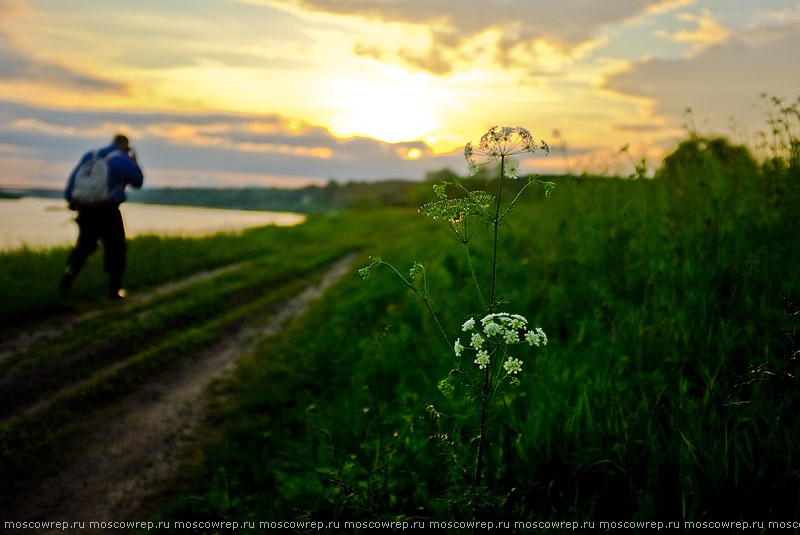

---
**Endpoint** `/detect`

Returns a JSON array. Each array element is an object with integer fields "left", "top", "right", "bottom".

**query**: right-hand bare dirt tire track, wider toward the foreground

[{"left": 6, "top": 254, "right": 356, "bottom": 526}]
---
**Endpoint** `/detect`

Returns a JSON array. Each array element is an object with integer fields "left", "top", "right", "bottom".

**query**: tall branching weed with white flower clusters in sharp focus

[{"left": 359, "top": 127, "right": 555, "bottom": 518}]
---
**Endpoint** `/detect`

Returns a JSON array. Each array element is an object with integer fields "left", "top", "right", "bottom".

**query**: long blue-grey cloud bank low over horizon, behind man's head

[{"left": 0, "top": 101, "right": 463, "bottom": 187}]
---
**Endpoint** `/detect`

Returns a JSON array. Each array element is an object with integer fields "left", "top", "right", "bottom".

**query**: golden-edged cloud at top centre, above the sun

[{"left": 256, "top": 0, "right": 686, "bottom": 74}]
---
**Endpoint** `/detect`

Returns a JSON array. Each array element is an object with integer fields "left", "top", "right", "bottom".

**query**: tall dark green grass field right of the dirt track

[{"left": 153, "top": 139, "right": 800, "bottom": 531}]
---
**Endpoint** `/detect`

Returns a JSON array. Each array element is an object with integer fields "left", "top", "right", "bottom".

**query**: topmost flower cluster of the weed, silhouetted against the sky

[{"left": 464, "top": 126, "right": 550, "bottom": 179}]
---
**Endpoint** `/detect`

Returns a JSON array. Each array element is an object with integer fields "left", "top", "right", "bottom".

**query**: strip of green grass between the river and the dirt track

[{"left": 0, "top": 216, "right": 363, "bottom": 330}]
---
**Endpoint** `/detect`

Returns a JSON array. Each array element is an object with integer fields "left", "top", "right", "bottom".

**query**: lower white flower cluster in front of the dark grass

[{"left": 454, "top": 312, "right": 547, "bottom": 375}]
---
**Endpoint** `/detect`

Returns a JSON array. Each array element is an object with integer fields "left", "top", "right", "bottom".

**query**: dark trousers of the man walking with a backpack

[{"left": 67, "top": 205, "right": 126, "bottom": 291}]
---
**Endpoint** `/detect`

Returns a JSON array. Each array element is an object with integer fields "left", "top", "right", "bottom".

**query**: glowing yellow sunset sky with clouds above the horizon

[{"left": 0, "top": 0, "right": 800, "bottom": 188}]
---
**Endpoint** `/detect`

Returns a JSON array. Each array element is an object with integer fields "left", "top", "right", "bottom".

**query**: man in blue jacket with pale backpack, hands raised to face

[{"left": 58, "top": 134, "right": 144, "bottom": 299}]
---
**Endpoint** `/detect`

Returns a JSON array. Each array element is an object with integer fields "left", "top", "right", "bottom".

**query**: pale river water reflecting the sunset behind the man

[{"left": 0, "top": 197, "right": 305, "bottom": 251}]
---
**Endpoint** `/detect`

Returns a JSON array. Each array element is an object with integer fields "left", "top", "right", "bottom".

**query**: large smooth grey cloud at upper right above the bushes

[{"left": 606, "top": 15, "right": 800, "bottom": 133}]
